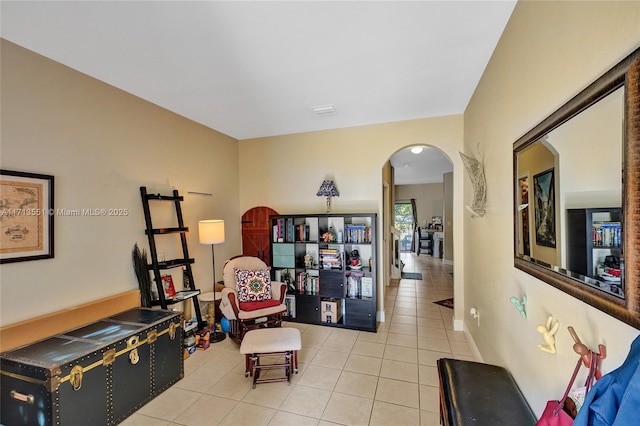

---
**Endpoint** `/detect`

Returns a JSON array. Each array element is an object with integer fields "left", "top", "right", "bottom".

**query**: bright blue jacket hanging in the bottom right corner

[{"left": 573, "top": 336, "right": 640, "bottom": 426}]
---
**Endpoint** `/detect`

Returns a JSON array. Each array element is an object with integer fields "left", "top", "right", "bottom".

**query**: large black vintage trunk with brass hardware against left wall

[{"left": 0, "top": 308, "right": 184, "bottom": 426}]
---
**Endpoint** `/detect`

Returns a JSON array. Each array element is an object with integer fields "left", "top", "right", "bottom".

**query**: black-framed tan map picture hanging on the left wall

[{"left": 0, "top": 170, "right": 55, "bottom": 263}]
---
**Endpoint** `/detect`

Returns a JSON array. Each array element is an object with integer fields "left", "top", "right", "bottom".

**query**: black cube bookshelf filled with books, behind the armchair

[{"left": 270, "top": 213, "right": 377, "bottom": 331}]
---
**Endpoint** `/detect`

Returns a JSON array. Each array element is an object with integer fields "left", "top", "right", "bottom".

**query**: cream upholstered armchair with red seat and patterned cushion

[{"left": 220, "top": 256, "right": 287, "bottom": 343}]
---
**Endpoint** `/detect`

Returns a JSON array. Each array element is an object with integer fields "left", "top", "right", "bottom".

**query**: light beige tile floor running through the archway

[{"left": 122, "top": 253, "right": 473, "bottom": 426}]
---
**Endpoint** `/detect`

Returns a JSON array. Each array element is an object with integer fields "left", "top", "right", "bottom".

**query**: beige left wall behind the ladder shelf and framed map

[{"left": 0, "top": 40, "right": 240, "bottom": 325}]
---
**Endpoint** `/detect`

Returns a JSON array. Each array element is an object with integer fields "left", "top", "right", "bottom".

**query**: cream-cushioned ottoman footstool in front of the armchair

[{"left": 240, "top": 327, "right": 302, "bottom": 389}]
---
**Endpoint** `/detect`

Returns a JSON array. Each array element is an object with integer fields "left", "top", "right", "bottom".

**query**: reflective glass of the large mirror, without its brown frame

[{"left": 516, "top": 88, "right": 624, "bottom": 298}]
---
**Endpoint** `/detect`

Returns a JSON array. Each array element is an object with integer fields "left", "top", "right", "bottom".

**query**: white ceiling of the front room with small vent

[{"left": 0, "top": 0, "right": 516, "bottom": 185}]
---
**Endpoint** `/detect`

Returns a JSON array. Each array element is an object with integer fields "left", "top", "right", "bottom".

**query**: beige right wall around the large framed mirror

[{"left": 464, "top": 1, "right": 640, "bottom": 413}]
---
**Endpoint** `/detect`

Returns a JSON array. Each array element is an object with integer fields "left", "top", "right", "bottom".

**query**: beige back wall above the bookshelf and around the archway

[{"left": 240, "top": 115, "right": 464, "bottom": 317}]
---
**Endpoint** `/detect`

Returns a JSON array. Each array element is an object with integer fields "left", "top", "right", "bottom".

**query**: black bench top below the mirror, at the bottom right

[{"left": 437, "top": 358, "right": 536, "bottom": 426}]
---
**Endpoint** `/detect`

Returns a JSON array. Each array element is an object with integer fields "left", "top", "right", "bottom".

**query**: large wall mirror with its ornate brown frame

[{"left": 513, "top": 49, "right": 640, "bottom": 328}]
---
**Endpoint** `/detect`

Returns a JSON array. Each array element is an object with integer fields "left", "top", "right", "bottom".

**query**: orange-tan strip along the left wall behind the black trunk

[{"left": 0, "top": 290, "right": 140, "bottom": 352}]
